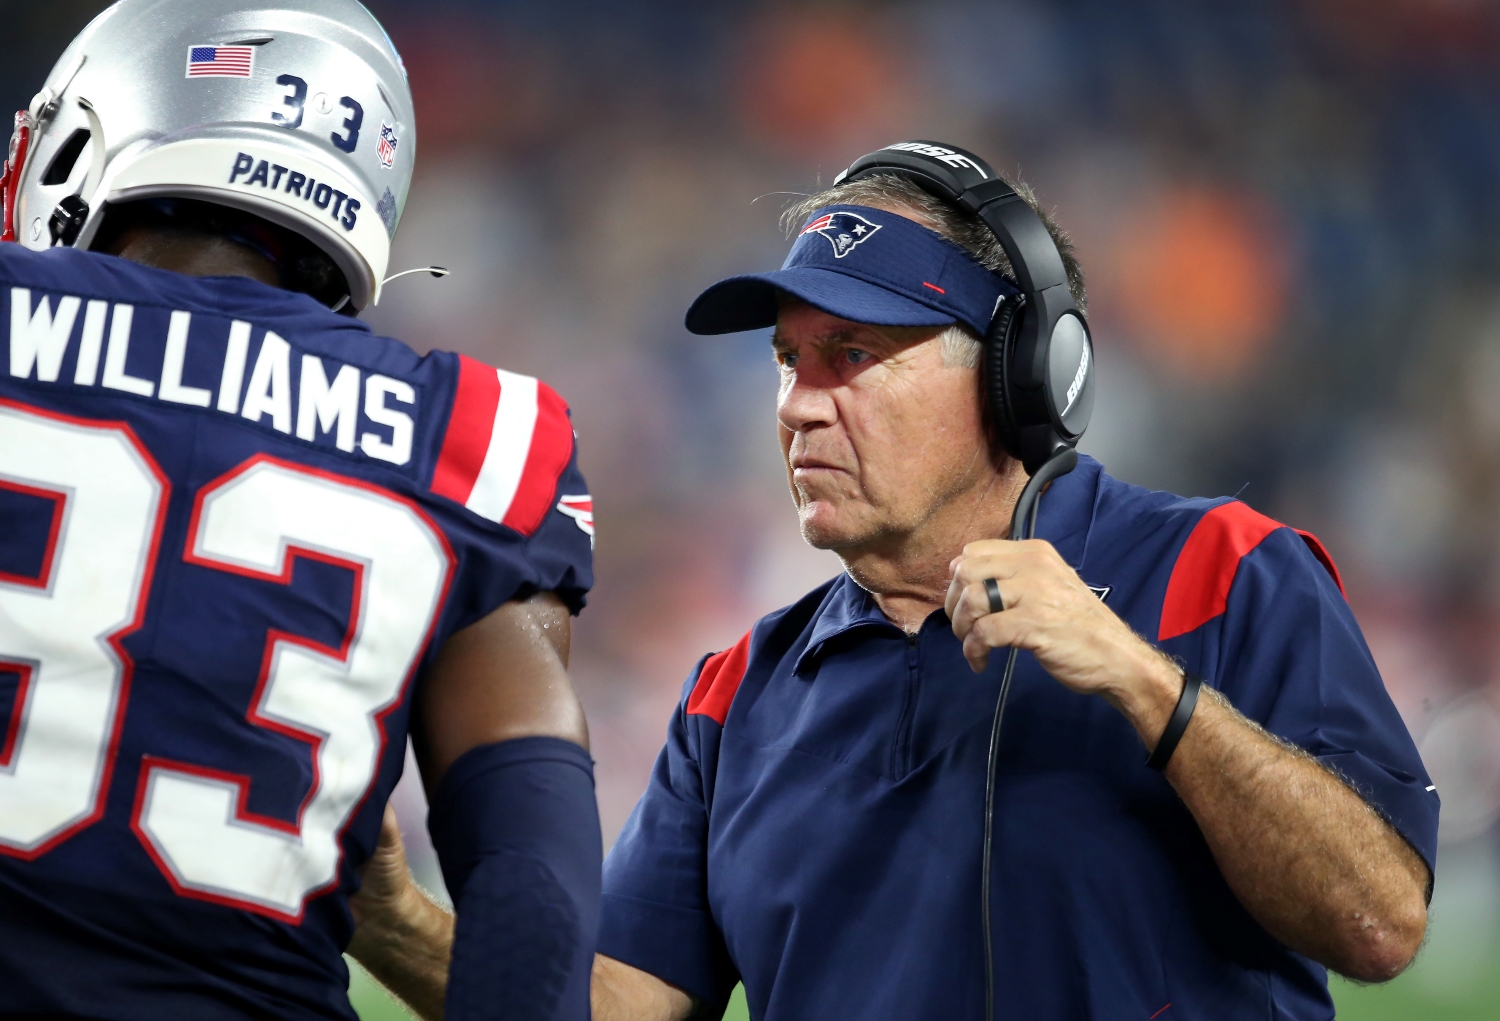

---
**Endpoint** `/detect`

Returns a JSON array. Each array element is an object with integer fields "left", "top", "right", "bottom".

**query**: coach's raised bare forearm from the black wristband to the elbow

[{"left": 1122, "top": 668, "right": 1430, "bottom": 982}]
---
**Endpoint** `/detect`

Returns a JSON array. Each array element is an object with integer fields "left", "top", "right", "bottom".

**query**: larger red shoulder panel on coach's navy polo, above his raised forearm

[{"left": 1157, "top": 499, "right": 1283, "bottom": 642}]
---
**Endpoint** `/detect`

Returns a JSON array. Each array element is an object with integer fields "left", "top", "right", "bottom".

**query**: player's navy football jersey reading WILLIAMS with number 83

[{"left": 0, "top": 244, "right": 594, "bottom": 1020}]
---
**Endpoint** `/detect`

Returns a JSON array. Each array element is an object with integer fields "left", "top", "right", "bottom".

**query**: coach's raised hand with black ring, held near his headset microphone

[{"left": 947, "top": 540, "right": 1182, "bottom": 707}]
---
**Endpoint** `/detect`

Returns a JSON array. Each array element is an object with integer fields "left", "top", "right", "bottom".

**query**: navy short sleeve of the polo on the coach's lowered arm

[{"left": 599, "top": 663, "right": 740, "bottom": 1005}]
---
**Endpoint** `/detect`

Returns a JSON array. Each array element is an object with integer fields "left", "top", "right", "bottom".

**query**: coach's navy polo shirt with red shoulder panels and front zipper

[{"left": 599, "top": 457, "right": 1439, "bottom": 1021}]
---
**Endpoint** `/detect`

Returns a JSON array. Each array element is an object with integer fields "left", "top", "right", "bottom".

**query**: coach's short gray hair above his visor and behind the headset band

[{"left": 782, "top": 174, "right": 1089, "bottom": 314}]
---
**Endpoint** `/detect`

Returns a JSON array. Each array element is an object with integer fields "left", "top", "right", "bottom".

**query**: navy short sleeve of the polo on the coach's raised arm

[{"left": 1209, "top": 528, "right": 1439, "bottom": 868}]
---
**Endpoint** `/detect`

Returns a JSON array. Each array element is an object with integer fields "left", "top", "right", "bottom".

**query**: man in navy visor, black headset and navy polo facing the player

[{"left": 345, "top": 142, "right": 1439, "bottom": 1021}]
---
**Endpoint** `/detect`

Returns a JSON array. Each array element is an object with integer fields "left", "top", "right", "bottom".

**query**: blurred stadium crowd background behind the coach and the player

[{"left": 0, "top": 0, "right": 1500, "bottom": 1021}]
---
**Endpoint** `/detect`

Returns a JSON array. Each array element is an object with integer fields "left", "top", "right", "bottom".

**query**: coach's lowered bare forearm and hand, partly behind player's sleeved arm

[{"left": 350, "top": 808, "right": 695, "bottom": 1021}]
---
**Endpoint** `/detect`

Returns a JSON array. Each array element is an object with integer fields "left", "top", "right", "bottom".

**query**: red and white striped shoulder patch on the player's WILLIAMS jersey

[{"left": 432, "top": 355, "right": 579, "bottom": 535}]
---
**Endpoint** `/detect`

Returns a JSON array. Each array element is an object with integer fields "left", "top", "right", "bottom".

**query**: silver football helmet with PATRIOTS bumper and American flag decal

[{"left": 0, "top": 0, "right": 417, "bottom": 309}]
